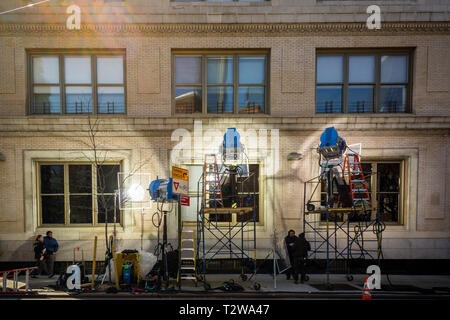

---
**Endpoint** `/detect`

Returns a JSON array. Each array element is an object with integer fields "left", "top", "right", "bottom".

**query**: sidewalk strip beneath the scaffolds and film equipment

[{"left": 0, "top": 274, "right": 450, "bottom": 299}]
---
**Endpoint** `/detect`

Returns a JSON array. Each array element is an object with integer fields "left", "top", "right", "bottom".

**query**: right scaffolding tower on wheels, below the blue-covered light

[{"left": 303, "top": 153, "right": 385, "bottom": 285}]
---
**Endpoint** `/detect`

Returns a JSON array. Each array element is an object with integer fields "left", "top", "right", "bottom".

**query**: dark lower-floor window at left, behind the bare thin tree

[{"left": 39, "top": 163, "right": 120, "bottom": 226}]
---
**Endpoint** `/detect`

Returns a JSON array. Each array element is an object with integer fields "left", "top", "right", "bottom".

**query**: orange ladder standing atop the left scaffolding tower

[{"left": 202, "top": 154, "right": 223, "bottom": 208}]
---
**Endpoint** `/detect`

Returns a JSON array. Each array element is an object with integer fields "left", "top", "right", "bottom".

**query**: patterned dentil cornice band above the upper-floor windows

[{"left": 0, "top": 22, "right": 450, "bottom": 35}]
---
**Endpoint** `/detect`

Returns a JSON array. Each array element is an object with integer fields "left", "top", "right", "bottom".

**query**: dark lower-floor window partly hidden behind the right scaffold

[{"left": 321, "top": 161, "right": 404, "bottom": 223}]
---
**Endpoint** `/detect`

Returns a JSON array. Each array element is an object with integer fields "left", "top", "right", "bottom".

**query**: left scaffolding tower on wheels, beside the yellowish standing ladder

[{"left": 197, "top": 155, "right": 258, "bottom": 274}]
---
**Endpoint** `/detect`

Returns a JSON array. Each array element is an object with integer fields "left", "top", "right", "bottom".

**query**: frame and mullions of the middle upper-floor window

[{"left": 171, "top": 49, "right": 270, "bottom": 117}]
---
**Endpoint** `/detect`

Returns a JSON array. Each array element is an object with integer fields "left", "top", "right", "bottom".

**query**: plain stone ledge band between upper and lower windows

[{"left": 0, "top": 115, "right": 450, "bottom": 136}]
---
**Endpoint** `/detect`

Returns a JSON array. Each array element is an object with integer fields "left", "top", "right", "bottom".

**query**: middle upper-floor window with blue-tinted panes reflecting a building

[{"left": 174, "top": 53, "right": 267, "bottom": 114}]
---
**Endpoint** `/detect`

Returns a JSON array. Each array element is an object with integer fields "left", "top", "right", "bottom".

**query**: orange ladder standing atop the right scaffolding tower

[{"left": 342, "top": 153, "right": 372, "bottom": 209}]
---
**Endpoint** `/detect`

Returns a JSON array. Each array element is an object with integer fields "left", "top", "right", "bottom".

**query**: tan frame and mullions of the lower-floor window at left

[{"left": 36, "top": 161, "right": 123, "bottom": 228}]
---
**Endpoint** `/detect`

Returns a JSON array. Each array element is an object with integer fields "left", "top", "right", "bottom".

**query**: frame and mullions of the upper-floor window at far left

[{"left": 27, "top": 49, "right": 127, "bottom": 116}]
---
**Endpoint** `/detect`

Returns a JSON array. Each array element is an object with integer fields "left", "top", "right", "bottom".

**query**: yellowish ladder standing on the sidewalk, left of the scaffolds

[{"left": 177, "top": 222, "right": 198, "bottom": 288}]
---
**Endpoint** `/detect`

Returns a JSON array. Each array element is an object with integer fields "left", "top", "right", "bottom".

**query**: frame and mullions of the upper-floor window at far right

[{"left": 314, "top": 48, "right": 414, "bottom": 115}]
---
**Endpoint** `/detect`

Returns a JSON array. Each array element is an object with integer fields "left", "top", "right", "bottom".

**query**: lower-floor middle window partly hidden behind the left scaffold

[{"left": 181, "top": 164, "right": 260, "bottom": 222}]
